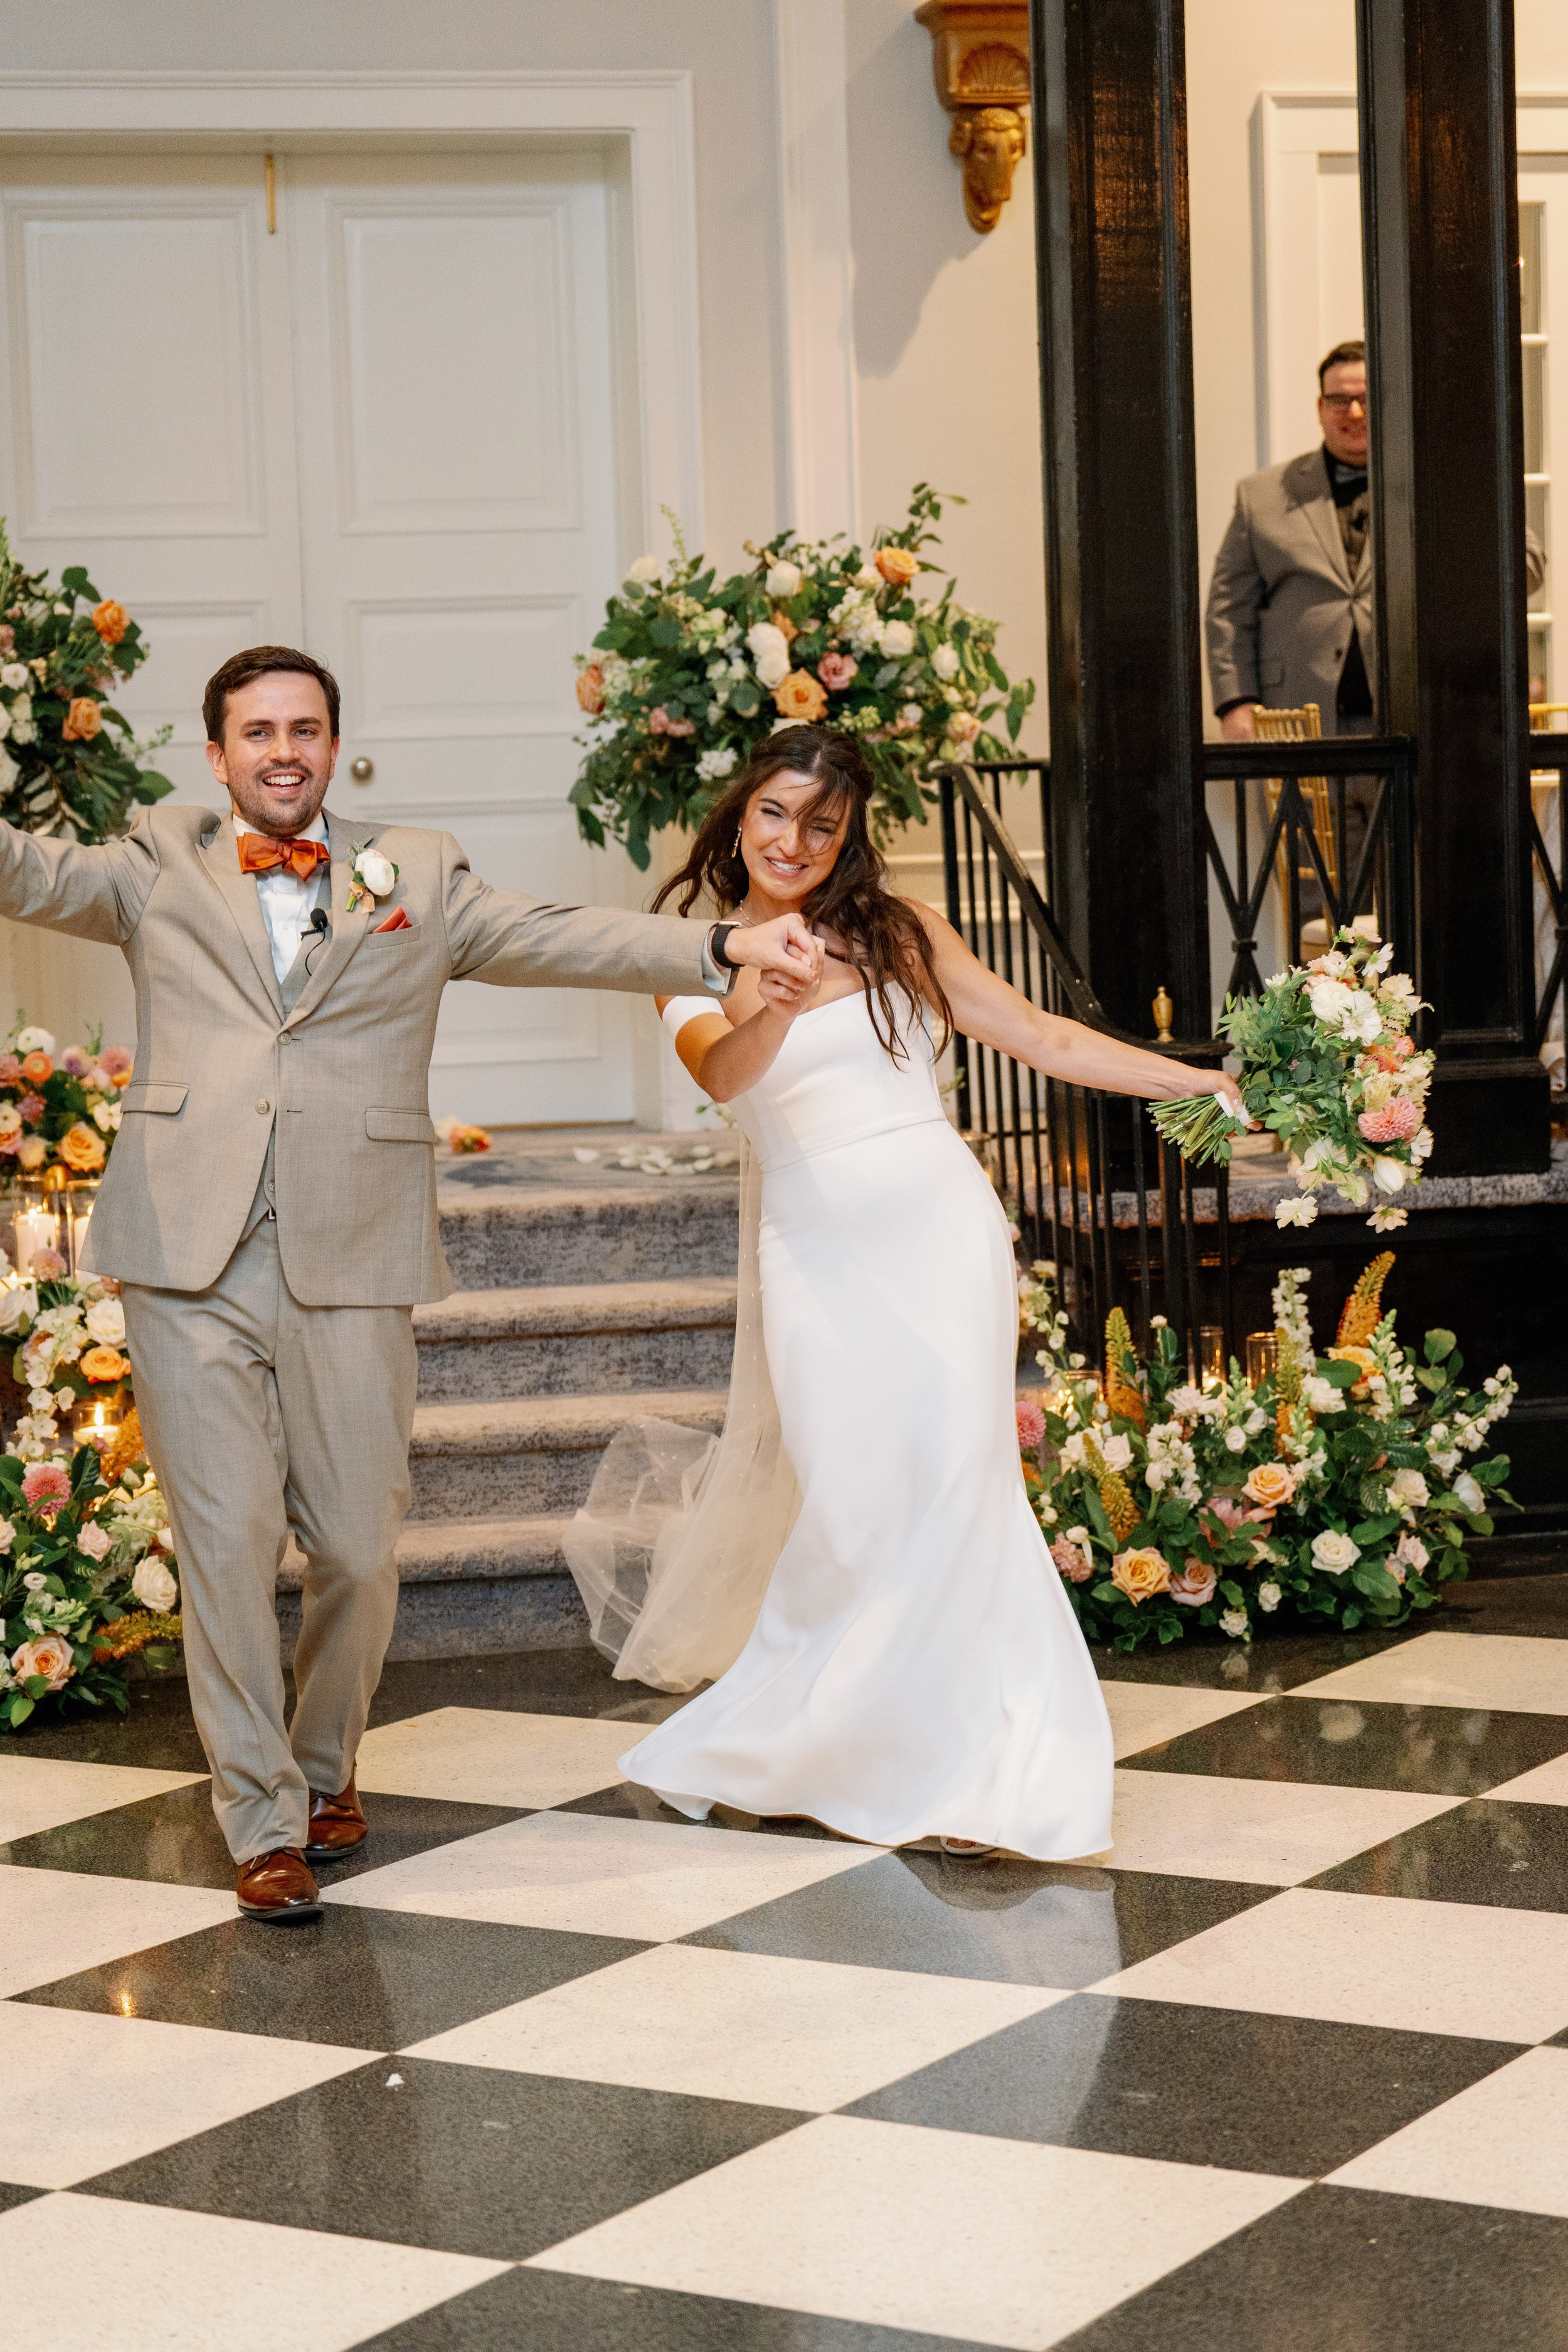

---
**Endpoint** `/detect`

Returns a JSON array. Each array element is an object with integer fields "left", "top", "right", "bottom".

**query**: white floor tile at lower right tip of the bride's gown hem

[{"left": 1107, "top": 1771, "right": 1460, "bottom": 1887}]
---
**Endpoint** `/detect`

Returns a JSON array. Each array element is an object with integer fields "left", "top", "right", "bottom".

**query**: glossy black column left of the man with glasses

[{"left": 1030, "top": 0, "right": 1210, "bottom": 1037}]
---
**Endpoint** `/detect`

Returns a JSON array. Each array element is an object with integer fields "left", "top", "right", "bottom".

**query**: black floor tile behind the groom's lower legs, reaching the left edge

[{"left": 0, "top": 1781, "right": 519, "bottom": 1887}]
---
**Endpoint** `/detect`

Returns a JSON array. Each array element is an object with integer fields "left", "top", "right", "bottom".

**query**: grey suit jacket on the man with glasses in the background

[{"left": 1204, "top": 449, "right": 1547, "bottom": 734}]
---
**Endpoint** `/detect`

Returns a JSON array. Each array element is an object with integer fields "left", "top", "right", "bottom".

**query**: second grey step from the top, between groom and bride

[{"left": 414, "top": 1275, "right": 736, "bottom": 1404}]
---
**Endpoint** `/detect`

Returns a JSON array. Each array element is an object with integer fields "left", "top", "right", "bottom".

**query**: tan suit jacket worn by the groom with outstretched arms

[{"left": 0, "top": 802, "right": 705, "bottom": 1305}]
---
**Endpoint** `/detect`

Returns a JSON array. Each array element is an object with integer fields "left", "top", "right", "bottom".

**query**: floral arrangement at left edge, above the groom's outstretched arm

[{"left": 0, "top": 520, "right": 174, "bottom": 842}]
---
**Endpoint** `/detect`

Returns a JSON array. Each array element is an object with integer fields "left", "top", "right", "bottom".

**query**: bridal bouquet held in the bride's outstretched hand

[{"left": 1152, "top": 931, "right": 1432, "bottom": 1232}]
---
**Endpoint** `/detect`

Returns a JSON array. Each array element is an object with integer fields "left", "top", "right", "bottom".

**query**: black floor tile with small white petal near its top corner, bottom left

[{"left": 78, "top": 2058, "right": 807, "bottom": 2263}]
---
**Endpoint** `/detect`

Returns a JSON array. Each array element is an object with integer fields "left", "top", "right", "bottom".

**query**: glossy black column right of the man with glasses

[{"left": 1359, "top": 0, "right": 1561, "bottom": 1173}]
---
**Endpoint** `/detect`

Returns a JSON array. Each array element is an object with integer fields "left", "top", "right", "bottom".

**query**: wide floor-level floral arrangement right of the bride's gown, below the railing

[{"left": 1018, "top": 1251, "right": 1517, "bottom": 1649}]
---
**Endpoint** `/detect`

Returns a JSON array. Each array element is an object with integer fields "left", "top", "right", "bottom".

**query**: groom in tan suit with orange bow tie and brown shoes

[{"left": 0, "top": 645, "right": 820, "bottom": 1919}]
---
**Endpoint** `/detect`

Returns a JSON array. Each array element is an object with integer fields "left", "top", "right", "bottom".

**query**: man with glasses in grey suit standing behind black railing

[{"left": 1206, "top": 341, "right": 1547, "bottom": 743}]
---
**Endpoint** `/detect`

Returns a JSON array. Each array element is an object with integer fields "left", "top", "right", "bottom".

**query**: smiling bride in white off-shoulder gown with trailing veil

[{"left": 566, "top": 727, "right": 1239, "bottom": 1860}]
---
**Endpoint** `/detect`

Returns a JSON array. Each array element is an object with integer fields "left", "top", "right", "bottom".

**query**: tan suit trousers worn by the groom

[{"left": 122, "top": 1216, "right": 418, "bottom": 1860}]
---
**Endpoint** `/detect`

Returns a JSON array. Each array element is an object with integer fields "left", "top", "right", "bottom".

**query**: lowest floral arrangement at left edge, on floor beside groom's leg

[{"left": 0, "top": 1446, "right": 181, "bottom": 1731}]
